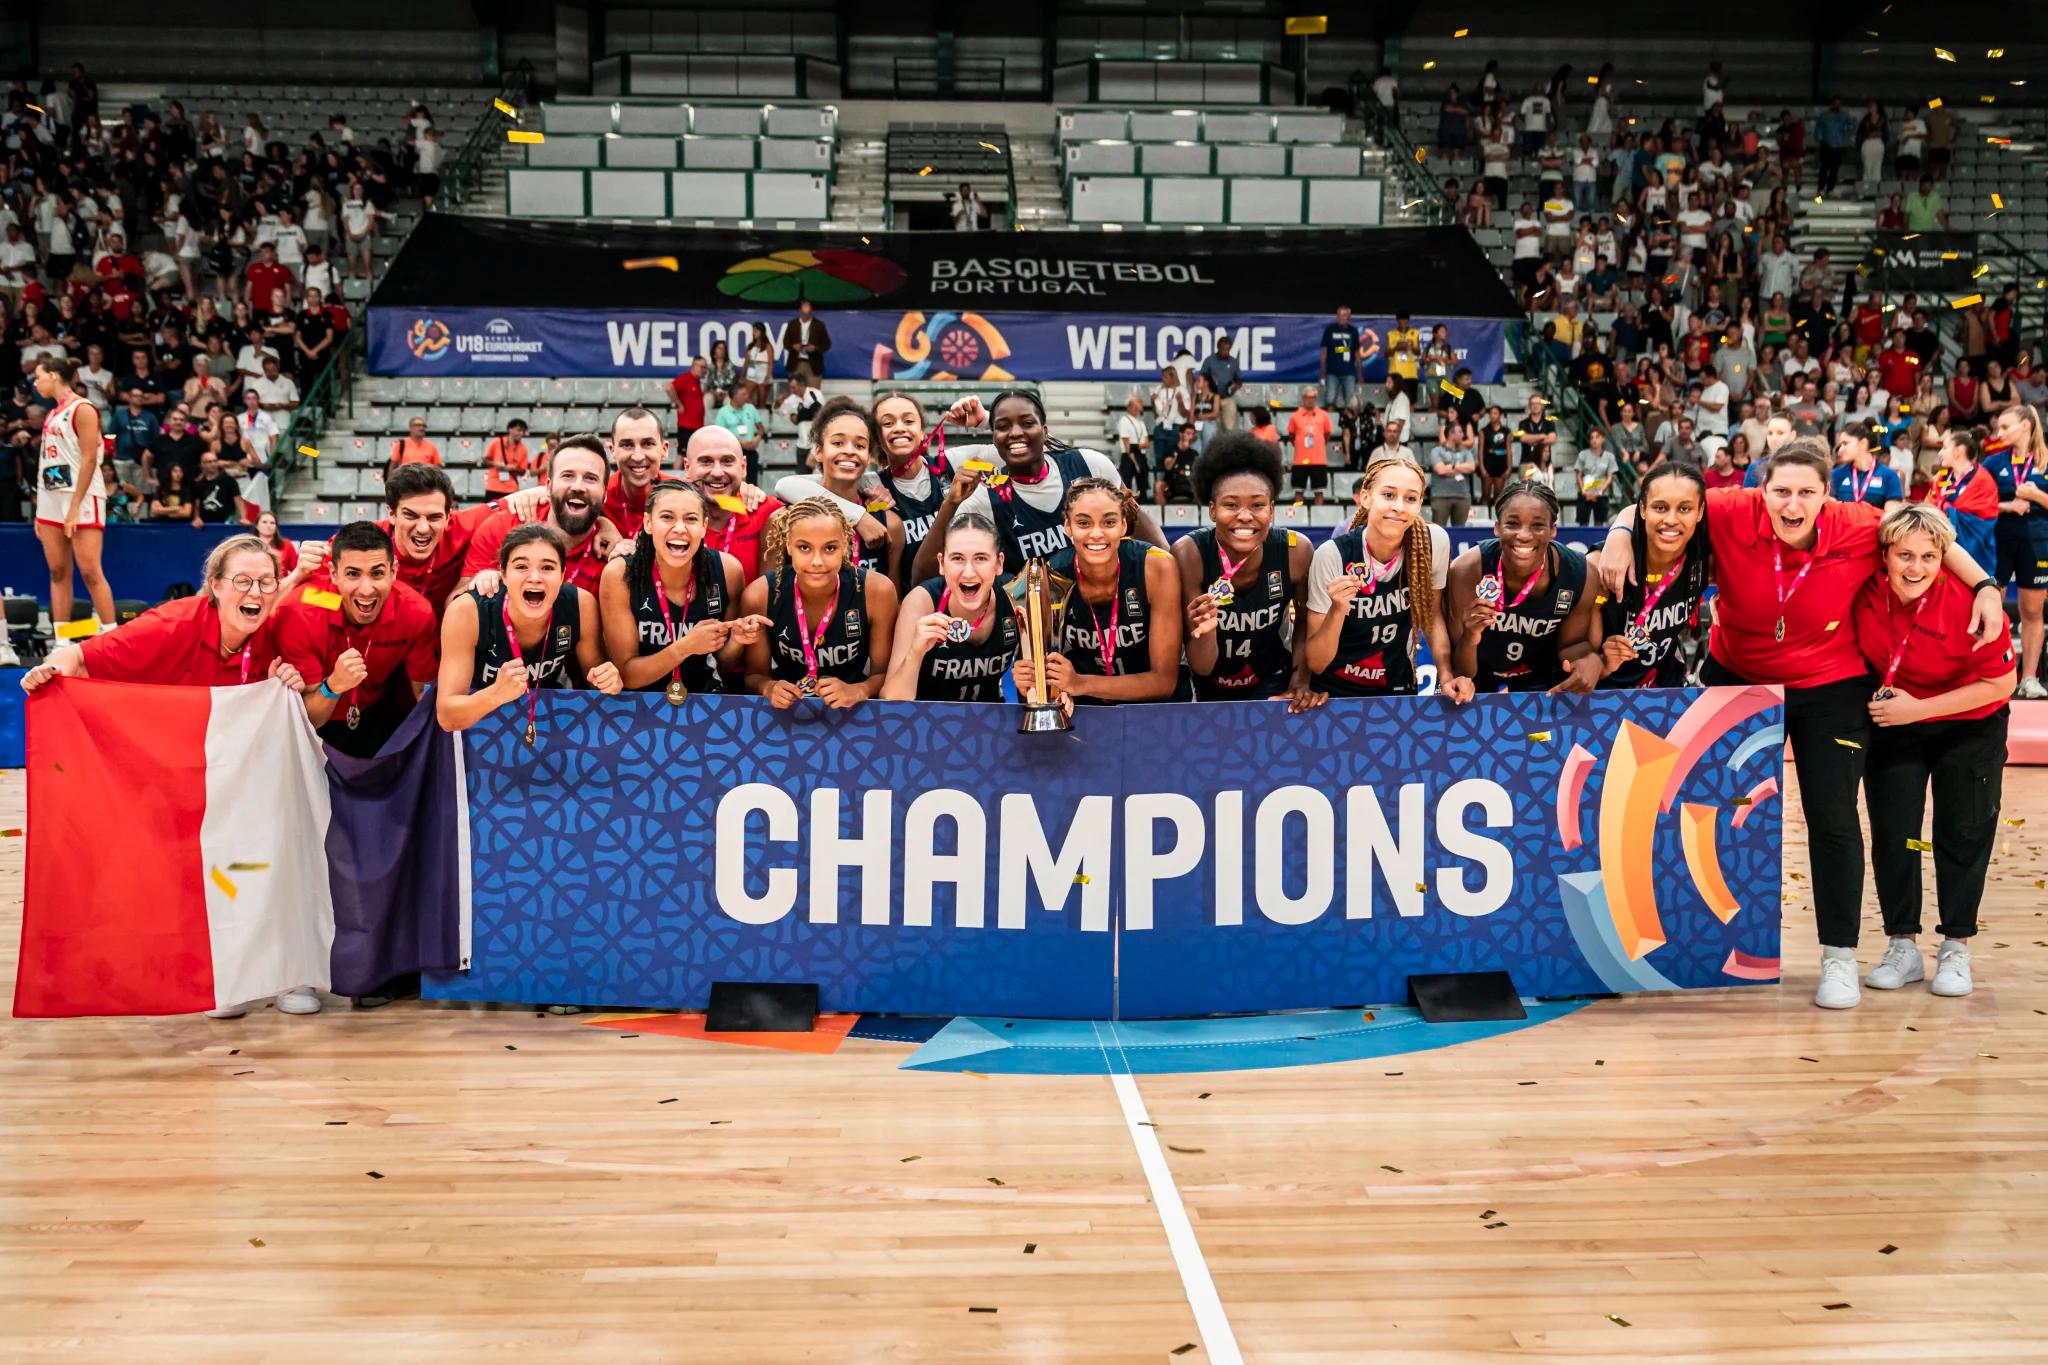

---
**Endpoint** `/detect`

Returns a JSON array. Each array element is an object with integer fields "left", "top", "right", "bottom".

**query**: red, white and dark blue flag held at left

[{"left": 14, "top": 679, "right": 467, "bottom": 1017}]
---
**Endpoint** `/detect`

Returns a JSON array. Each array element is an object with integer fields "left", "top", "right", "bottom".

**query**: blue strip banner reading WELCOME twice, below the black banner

[{"left": 369, "top": 307, "right": 1505, "bottom": 385}]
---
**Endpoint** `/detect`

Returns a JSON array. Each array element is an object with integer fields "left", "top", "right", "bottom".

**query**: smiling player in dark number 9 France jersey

[{"left": 1450, "top": 479, "right": 1602, "bottom": 694}]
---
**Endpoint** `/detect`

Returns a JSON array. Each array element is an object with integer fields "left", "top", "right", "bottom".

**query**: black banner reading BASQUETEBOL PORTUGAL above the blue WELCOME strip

[{"left": 371, "top": 213, "right": 1520, "bottom": 319}]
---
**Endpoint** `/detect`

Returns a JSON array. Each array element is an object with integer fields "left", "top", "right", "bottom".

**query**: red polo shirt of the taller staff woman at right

[{"left": 1706, "top": 489, "right": 1882, "bottom": 688}]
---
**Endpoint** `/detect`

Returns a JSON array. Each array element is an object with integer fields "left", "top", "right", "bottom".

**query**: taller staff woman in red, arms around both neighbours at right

[{"left": 1602, "top": 438, "right": 2005, "bottom": 1009}]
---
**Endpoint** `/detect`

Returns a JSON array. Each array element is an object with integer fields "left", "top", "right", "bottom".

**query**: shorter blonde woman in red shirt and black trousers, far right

[{"left": 1853, "top": 503, "right": 2019, "bottom": 995}]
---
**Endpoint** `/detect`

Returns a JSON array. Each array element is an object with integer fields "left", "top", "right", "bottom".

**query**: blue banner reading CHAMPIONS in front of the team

[{"left": 428, "top": 688, "right": 1784, "bottom": 1019}]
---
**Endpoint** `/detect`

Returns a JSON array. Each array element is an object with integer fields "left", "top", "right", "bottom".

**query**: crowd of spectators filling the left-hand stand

[{"left": 0, "top": 65, "right": 440, "bottom": 520}]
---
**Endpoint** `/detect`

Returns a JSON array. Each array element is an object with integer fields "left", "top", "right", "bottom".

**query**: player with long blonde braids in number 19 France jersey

[{"left": 1307, "top": 454, "right": 1473, "bottom": 704}]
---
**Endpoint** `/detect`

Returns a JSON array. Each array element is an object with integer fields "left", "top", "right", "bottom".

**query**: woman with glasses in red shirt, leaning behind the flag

[{"left": 20, "top": 536, "right": 322, "bottom": 687}]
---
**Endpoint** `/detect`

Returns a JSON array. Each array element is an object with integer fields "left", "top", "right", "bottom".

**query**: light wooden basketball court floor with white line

[{"left": 0, "top": 769, "right": 2048, "bottom": 1365}]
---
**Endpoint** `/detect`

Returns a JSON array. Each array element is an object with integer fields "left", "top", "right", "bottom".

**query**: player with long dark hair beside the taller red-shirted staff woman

[{"left": 1593, "top": 460, "right": 1714, "bottom": 688}]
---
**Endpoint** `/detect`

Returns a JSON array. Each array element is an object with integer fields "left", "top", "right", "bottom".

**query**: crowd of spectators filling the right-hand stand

[{"left": 1438, "top": 63, "right": 2048, "bottom": 501}]
